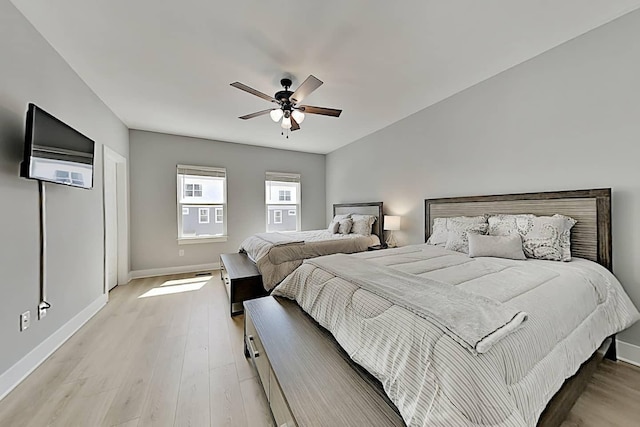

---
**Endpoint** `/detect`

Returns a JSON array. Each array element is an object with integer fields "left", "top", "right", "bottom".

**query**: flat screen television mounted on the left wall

[{"left": 20, "top": 104, "right": 95, "bottom": 188}]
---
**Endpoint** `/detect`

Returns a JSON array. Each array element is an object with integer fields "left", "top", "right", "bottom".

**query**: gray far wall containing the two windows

[{"left": 129, "top": 130, "right": 326, "bottom": 271}]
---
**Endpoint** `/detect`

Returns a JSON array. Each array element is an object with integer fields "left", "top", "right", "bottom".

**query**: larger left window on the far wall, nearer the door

[{"left": 177, "top": 165, "right": 227, "bottom": 244}]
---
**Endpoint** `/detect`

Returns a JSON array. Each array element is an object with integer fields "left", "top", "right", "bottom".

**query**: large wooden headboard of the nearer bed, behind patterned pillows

[{"left": 424, "top": 188, "right": 613, "bottom": 271}]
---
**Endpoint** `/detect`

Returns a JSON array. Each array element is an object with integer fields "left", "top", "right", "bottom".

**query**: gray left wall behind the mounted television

[{"left": 0, "top": 0, "right": 128, "bottom": 374}]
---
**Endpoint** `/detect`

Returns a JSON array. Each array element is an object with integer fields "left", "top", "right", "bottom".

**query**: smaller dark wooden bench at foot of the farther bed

[{"left": 220, "top": 253, "right": 268, "bottom": 316}]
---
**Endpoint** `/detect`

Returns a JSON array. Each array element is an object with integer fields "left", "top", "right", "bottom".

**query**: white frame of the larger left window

[{"left": 176, "top": 165, "right": 228, "bottom": 245}]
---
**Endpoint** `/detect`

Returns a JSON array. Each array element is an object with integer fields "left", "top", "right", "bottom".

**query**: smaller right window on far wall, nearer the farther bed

[{"left": 265, "top": 172, "right": 300, "bottom": 232}]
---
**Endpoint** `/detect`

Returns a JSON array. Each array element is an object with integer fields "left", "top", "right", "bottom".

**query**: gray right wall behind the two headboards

[{"left": 326, "top": 12, "right": 640, "bottom": 345}]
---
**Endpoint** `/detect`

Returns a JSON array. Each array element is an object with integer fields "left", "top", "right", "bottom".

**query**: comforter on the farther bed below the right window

[{"left": 240, "top": 230, "right": 380, "bottom": 291}]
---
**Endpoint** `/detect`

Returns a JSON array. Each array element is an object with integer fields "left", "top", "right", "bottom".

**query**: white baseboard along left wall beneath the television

[{"left": 0, "top": 294, "right": 107, "bottom": 400}]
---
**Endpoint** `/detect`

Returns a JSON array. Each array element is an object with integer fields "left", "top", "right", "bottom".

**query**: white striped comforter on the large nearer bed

[{"left": 273, "top": 245, "right": 640, "bottom": 426}]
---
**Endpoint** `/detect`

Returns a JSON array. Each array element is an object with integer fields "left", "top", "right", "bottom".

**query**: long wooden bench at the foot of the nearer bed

[{"left": 244, "top": 297, "right": 404, "bottom": 427}]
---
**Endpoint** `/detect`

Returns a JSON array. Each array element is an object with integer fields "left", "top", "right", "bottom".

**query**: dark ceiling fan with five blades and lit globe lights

[{"left": 231, "top": 76, "right": 342, "bottom": 138}]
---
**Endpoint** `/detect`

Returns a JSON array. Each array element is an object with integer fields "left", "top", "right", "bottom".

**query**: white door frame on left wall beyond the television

[{"left": 102, "top": 145, "right": 129, "bottom": 298}]
